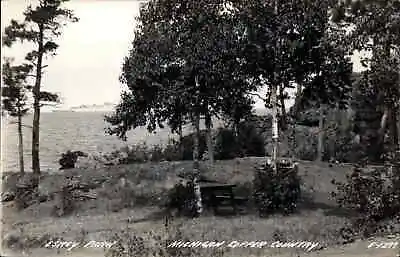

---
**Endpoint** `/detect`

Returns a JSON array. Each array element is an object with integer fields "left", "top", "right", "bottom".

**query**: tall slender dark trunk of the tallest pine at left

[{"left": 32, "top": 25, "right": 44, "bottom": 177}]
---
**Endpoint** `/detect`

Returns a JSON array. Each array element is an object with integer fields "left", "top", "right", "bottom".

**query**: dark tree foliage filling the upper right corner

[{"left": 333, "top": 0, "right": 400, "bottom": 151}]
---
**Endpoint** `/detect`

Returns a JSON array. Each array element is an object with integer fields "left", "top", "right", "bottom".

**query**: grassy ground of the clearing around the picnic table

[{"left": 2, "top": 158, "right": 400, "bottom": 257}]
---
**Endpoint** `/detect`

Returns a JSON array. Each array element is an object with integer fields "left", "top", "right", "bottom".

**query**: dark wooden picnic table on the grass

[{"left": 199, "top": 181, "right": 247, "bottom": 213}]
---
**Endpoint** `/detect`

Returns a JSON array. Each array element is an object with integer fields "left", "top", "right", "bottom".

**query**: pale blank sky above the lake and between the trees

[{"left": 1, "top": 0, "right": 366, "bottom": 108}]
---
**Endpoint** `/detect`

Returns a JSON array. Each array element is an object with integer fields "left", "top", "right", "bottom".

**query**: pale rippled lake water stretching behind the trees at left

[{"left": 2, "top": 112, "right": 223, "bottom": 171}]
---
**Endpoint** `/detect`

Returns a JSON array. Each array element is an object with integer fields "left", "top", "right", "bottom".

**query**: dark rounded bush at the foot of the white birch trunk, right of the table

[{"left": 253, "top": 163, "right": 300, "bottom": 216}]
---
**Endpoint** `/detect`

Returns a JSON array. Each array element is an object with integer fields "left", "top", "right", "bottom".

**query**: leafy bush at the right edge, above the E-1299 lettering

[{"left": 332, "top": 161, "right": 400, "bottom": 236}]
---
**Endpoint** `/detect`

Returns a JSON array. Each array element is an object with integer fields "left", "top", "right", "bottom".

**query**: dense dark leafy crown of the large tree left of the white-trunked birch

[{"left": 106, "top": 0, "right": 249, "bottom": 138}]
